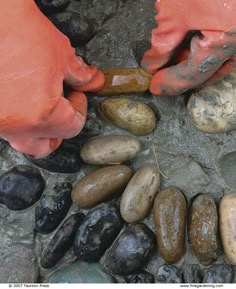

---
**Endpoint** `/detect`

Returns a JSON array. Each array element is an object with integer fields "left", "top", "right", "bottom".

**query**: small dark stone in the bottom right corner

[{"left": 203, "top": 264, "right": 234, "bottom": 283}]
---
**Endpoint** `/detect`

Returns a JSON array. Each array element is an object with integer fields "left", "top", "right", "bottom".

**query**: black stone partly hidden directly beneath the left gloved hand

[{"left": 26, "top": 141, "right": 81, "bottom": 174}]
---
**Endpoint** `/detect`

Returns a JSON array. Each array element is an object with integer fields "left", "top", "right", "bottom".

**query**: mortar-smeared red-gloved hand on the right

[{"left": 141, "top": 0, "right": 236, "bottom": 95}]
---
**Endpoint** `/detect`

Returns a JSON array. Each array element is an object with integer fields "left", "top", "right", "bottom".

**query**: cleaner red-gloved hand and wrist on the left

[{"left": 0, "top": 0, "right": 105, "bottom": 158}]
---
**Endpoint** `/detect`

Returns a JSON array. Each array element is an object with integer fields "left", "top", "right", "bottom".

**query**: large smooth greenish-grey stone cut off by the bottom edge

[{"left": 45, "top": 261, "right": 115, "bottom": 283}]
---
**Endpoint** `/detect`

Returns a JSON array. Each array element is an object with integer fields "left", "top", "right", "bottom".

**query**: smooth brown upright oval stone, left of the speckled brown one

[{"left": 153, "top": 187, "right": 186, "bottom": 264}]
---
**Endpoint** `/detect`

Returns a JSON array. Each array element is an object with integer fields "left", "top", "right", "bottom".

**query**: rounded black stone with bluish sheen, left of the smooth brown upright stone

[{"left": 107, "top": 224, "right": 155, "bottom": 275}]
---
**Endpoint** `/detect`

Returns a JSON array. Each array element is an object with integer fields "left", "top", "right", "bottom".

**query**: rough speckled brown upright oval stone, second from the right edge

[{"left": 188, "top": 194, "right": 219, "bottom": 265}]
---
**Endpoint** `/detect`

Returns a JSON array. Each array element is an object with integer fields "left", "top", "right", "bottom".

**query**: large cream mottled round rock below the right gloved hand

[{"left": 188, "top": 71, "right": 236, "bottom": 133}]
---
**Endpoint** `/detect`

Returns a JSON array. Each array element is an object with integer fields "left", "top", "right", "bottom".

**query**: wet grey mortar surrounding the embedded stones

[{"left": 0, "top": 0, "right": 236, "bottom": 282}]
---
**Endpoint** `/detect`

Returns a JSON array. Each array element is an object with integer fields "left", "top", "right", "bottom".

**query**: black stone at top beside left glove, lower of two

[{"left": 50, "top": 12, "right": 94, "bottom": 47}]
